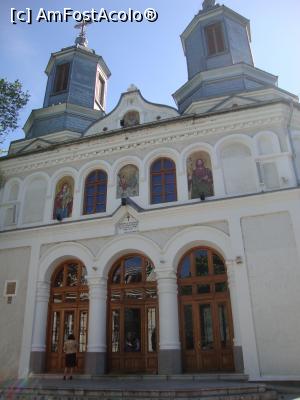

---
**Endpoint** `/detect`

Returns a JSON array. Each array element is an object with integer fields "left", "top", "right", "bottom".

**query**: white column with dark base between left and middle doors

[{"left": 85, "top": 277, "right": 107, "bottom": 375}]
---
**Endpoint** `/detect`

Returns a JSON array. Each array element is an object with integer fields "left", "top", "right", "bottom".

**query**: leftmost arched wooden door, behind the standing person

[{"left": 46, "top": 260, "right": 89, "bottom": 372}]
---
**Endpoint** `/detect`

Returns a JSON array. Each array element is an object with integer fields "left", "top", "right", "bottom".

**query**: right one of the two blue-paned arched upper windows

[{"left": 150, "top": 158, "right": 177, "bottom": 204}]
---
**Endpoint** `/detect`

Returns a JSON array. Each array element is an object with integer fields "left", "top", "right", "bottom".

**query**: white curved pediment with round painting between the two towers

[{"left": 84, "top": 85, "right": 179, "bottom": 136}]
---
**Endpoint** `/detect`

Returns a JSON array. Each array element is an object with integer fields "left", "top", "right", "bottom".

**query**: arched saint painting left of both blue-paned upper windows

[{"left": 53, "top": 176, "right": 74, "bottom": 220}]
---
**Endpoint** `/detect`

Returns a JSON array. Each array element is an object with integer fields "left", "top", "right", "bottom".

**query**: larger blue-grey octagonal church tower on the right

[{"left": 173, "top": 0, "right": 277, "bottom": 113}]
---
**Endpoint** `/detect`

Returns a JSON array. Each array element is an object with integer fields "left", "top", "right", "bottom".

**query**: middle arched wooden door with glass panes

[{"left": 107, "top": 254, "right": 158, "bottom": 373}]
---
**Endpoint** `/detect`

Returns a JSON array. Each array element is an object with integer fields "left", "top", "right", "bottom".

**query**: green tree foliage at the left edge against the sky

[{"left": 0, "top": 79, "right": 29, "bottom": 143}]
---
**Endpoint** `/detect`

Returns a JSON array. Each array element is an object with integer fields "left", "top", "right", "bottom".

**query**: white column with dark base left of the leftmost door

[{"left": 30, "top": 282, "right": 50, "bottom": 373}]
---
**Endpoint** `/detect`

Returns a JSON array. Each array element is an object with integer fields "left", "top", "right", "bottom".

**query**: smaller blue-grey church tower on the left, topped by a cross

[{"left": 24, "top": 24, "right": 111, "bottom": 142}]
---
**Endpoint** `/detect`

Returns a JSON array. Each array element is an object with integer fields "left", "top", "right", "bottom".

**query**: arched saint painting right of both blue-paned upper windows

[{"left": 187, "top": 151, "right": 214, "bottom": 199}]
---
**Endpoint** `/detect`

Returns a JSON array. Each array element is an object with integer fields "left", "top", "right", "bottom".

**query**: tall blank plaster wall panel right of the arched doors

[{"left": 242, "top": 212, "right": 300, "bottom": 376}]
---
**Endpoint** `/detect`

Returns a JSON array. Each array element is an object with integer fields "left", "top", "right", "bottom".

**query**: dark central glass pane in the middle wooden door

[{"left": 124, "top": 308, "right": 141, "bottom": 352}]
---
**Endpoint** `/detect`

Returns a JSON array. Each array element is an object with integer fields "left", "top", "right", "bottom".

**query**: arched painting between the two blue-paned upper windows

[{"left": 117, "top": 165, "right": 139, "bottom": 199}]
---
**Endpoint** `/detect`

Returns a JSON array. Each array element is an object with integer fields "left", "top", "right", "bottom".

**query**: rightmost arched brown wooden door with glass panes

[{"left": 178, "top": 247, "right": 234, "bottom": 372}]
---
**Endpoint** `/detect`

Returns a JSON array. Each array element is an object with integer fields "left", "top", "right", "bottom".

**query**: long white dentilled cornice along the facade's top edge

[{"left": 2, "top": 108, "right": 287, "bottom": 177}]
